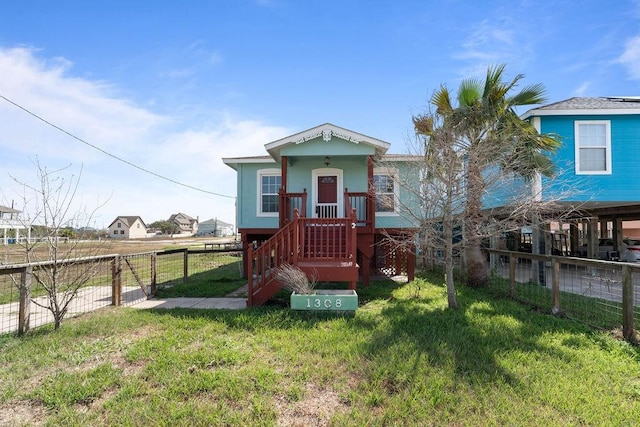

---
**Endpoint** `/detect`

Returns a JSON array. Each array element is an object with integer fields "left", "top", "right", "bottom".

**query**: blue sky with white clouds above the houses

[{"left": 0, "top": 0, "right": 640, "bottom": 231}]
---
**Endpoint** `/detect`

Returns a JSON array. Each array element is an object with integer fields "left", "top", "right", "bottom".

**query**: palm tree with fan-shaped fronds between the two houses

[{"left": 432, "top": 65, "right": 560, "bottom": 287}]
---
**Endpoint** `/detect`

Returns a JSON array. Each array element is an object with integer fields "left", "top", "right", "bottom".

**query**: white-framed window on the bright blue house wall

[{"left": 575, "top": 120, "right": 611, "bottom": 175}]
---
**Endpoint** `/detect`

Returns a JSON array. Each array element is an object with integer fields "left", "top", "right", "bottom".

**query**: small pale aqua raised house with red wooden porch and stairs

[{"left": 223, "top": 123, "right": 419, "bottom": 305}]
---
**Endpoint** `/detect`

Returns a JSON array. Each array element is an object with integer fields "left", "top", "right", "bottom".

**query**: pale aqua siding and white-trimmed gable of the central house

[{"left": 224, "top": 124, "right": 420, "bottom": 230}]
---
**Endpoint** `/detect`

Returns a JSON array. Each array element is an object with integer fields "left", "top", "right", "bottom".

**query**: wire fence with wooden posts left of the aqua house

[{"left": 0, "top": 249, "right": 242, "bottom": 334}]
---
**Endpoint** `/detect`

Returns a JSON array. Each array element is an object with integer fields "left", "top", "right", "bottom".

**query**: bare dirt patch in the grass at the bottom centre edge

[{"left": 276, "top": 384, "right": 348, "bottom": 427}]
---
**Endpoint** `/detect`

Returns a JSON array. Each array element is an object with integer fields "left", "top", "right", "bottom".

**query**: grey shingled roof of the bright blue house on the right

[{"left": 522, "top": 96, "right": 640, "bottom": 119}]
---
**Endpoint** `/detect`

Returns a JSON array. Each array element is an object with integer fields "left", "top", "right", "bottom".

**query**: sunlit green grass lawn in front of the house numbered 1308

[{"left": 0, "top": 272, "right": 640, "bottom": 426}]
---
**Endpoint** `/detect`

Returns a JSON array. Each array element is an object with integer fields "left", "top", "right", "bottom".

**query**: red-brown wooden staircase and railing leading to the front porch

[{"left": 247, "top": 209, "right": 358, "bottom": 306}]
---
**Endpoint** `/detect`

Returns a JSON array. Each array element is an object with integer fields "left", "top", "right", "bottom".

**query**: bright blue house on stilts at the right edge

[{"left": 522, "top": 97, "right": 640, "bottom": 257}]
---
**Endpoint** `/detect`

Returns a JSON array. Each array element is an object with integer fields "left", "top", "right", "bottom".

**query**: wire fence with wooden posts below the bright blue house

[{"left": 489, "top": 250, "right": 640, "bottom": 340}]
